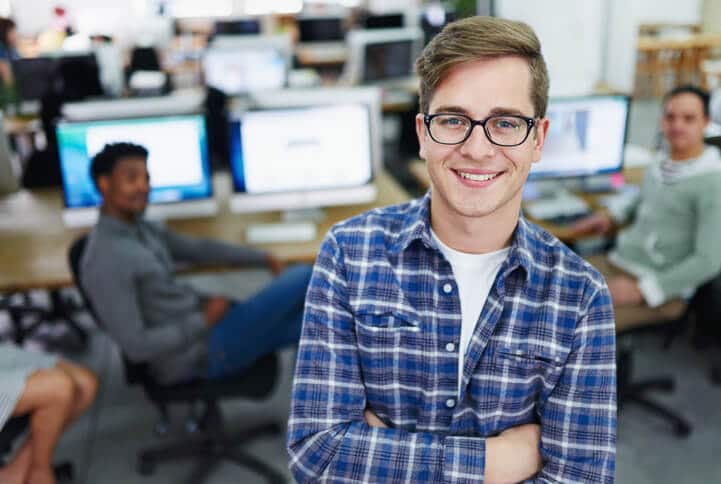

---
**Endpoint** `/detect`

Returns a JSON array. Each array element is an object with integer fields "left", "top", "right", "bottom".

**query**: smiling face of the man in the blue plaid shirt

[{"left": 416, "top": 57, "right": 548, "bottom": 221}]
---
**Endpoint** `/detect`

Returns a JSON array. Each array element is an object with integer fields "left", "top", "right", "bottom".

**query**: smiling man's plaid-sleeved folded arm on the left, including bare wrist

[{"left": 288, "top": 233, "right": 537, "bottom": 483}]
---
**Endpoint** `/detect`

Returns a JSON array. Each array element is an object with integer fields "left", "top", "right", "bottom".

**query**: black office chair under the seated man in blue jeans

[{"left": 68, "top": 236, "right": 286, "bottom": 484}]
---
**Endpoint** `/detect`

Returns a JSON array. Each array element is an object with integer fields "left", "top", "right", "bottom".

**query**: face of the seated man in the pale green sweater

[{"left": 661, "top": 92, "right": 709, "bottom": 152}]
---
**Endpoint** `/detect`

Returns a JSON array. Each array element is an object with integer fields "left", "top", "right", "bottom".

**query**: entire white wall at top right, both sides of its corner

[{"left": 496, "top": 0, "right": 703, "bottom": 95}]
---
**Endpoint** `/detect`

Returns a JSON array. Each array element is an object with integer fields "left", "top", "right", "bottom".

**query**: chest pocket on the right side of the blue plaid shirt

[{"left": 471, "top": 342, "right": 566, "bottom": 428}]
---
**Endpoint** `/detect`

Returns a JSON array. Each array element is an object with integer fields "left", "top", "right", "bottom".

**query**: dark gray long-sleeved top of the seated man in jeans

[{"left": 81, "top": 214, "right": 266, "bottom": 384}]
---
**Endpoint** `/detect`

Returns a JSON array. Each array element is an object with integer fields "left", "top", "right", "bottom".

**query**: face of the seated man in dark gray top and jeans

[{"left": 98, "top": 157, "right": 150, "bottom": 218}]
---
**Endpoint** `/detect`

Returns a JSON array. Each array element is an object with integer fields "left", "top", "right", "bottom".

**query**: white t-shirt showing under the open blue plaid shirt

[{"left": 431, "top": 230, "right": 510, "bottom": 394}]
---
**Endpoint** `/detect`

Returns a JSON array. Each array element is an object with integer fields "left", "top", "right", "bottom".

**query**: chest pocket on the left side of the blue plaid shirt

[{"left": 355, "top": 308, "right": 425, "bottom": 408}]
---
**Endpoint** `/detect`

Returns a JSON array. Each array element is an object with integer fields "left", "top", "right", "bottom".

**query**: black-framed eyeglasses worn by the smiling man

[{"left": 423, "top": 113, "right": 536, "bottom": 147}]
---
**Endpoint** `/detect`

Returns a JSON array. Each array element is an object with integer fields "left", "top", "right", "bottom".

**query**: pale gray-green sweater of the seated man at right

[{"left": 609, "top": 147, "right": 721, "bottom": 306}]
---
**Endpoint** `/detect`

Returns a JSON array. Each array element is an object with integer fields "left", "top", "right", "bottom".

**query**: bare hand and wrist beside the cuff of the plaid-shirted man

[{"left": 484, "top": 424, "right": 543, "bottom": 484}]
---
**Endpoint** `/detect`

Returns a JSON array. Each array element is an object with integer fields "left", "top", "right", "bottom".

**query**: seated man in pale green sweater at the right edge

[{"left": 575, "top": 86, "right": 721, "bottom": 316}]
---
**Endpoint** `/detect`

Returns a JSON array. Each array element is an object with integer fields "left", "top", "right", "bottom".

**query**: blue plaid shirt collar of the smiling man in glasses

[{"left": 389, "top": 190, "right": 540, "bottom": 281}]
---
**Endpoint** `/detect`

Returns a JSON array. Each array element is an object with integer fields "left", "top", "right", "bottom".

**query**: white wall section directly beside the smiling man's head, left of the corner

[{"left": 496, "top": 0, "right": 605, "bottom": 96}]
